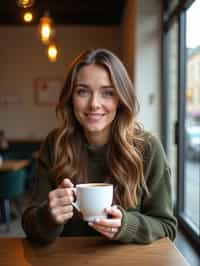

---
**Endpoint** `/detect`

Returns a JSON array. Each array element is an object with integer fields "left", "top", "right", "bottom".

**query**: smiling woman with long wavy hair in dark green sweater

[{"left": 22, "top": 49, "right": 176, "bottom": 243}]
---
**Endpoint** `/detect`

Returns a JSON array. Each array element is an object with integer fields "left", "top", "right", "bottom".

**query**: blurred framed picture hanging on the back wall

[{"left": 34, "top": 77, "right": 63, "bottom": 106}]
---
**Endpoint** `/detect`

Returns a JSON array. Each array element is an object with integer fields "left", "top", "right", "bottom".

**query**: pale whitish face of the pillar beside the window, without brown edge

[{"left": 135, "top": 0, "right": 162, "bottom": 134}]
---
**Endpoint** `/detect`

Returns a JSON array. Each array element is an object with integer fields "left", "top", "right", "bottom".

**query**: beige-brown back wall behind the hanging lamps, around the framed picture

[{"left": 0, "top": 26, "right": 121, "bottom": 139}]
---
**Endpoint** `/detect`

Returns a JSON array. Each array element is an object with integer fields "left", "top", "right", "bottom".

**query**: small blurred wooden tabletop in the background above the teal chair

[{"left": 0, "top": 160, "right": 29, "bottom": 172}]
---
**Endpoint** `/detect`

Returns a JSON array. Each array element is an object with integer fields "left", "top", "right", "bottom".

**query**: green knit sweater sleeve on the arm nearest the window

[{"left": 115, "top": 135, "right": 176, "bottom": 244}]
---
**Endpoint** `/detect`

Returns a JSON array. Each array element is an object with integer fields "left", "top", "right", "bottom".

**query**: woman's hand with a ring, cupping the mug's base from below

[{"left": 88, "top": 206, "right": 122, "bottom": 239}]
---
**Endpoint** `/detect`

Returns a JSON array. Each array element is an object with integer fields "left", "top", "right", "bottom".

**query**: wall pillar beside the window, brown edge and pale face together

[{"left": 121, "top": 0, "right": 162, "bottom": 135}]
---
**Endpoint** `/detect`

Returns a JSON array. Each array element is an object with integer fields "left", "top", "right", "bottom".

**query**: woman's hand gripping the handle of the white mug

[{"left": 48, "top": 178, "right": 74, "bottom": 224}]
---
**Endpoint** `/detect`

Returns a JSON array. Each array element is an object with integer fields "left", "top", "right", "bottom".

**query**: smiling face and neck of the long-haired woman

[{"left": 73, "top": 65, "right": 119, "bottom": 144}]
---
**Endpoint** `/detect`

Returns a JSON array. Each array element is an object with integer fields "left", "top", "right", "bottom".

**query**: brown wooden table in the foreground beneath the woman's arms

[{"left": 0, "top": 237, "right": 189, "bottom": 266}]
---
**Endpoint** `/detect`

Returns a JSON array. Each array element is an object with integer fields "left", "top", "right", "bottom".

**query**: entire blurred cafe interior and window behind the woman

[{"left": 0, "top": 0, "right": 200, "bottom": 265}]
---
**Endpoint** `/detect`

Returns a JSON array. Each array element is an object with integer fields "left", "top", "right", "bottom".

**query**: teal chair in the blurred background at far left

[{"left": 0, "top": 169, "right": 26, "bottom": 231}]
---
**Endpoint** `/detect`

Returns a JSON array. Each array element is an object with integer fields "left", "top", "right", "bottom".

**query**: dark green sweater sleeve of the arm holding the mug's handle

[{"left": 22, "top": 132, "right": 64, "bottom": 243}]
